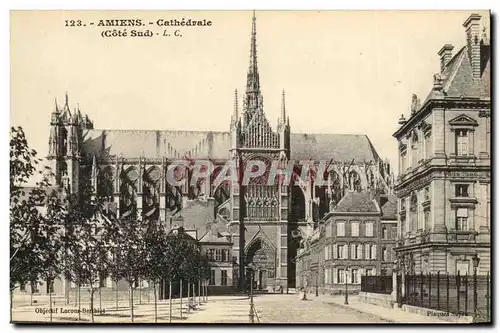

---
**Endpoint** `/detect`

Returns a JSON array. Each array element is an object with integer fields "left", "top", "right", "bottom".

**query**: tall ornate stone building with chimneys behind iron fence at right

[{"left": 394, "top": 14, "right": 491, "bottom": 274}]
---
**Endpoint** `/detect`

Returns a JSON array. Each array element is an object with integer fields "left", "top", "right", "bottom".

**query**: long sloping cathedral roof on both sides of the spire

[{"left": 84, "top": 129, "right": 379, "bottom": 161}]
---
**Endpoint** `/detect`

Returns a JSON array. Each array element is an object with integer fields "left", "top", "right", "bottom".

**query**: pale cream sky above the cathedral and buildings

[{"left": 10, "top": 11, "right": 487, "bottom": 184}]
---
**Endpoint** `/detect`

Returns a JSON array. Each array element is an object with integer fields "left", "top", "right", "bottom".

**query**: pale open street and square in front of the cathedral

[{"left": 9, "top": 294, "right": 388, "bottom": 323}]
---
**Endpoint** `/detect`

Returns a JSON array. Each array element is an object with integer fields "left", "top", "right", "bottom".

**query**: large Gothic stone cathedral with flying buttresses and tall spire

[{"left": 48, "top": 15, "right": 393, "bottom": 287}]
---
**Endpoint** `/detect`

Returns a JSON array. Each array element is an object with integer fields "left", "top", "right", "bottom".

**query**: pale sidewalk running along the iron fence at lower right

[{"left": 316, "top": 295, "right": 463, "bottom": 324}]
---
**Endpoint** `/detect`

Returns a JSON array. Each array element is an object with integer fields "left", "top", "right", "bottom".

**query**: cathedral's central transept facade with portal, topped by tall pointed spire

[{"left": 230, "top": 12, "right": 290, "bottom": 288}]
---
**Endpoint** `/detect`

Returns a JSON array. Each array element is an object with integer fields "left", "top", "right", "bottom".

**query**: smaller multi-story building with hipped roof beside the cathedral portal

[{"left": 297, "top": 191, "right": 397, "bottom": 293}]
